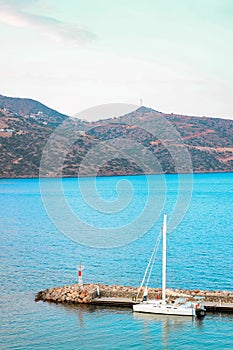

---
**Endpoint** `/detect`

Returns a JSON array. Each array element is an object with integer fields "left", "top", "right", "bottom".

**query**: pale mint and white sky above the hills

[{"left": 0, "top": 0, "right": 233, "bottom": 119}]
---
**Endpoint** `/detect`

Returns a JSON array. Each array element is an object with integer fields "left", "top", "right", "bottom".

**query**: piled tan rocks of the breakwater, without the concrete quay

[{"left": 35, "top": 284, "right": 233, "bottom": 304}]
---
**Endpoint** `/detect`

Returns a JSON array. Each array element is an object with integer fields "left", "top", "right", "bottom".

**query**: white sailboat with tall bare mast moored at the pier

[{"left": 133, "top": 214, "right": 206, "bottom": 317}]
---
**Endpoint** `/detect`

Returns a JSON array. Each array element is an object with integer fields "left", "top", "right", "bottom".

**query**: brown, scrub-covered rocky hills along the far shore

[{"left": 0, "top": 96, "right": 233, "bottom": 178}]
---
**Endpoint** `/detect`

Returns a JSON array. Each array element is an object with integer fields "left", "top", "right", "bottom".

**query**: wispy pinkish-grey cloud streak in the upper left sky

[{"left": 0, "top": 0, "right": 96, "bottom": 45}]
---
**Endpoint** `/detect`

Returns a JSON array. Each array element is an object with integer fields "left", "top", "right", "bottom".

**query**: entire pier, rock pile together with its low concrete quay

[{"left": 35, "top": 284, "right": 233, "bottom": 313}]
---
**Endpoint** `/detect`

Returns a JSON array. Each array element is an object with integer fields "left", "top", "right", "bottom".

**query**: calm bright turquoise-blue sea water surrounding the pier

[{"left": 0, "top": 173, "right": 233, "bottom": 350}]
